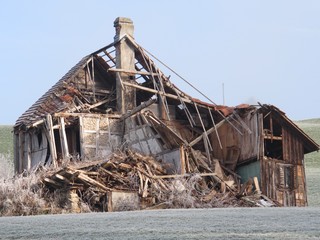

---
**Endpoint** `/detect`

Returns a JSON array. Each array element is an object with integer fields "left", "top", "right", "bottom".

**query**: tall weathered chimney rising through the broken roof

[{"left": 114, "top": 17, "right": 136, "bottom": 113}]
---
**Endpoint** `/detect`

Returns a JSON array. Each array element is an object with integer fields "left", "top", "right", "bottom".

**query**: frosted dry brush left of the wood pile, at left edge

[{"left": 0, "top": 167, "right": 90, "bottom": 216}]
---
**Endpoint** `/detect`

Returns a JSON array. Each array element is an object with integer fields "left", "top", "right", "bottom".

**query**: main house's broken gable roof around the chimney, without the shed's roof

[{"left": 14, "top": 36, "right": 239, "bottom": 128}]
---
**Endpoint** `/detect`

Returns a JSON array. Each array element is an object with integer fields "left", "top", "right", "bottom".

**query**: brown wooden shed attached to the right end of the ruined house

[{"left": 211, "top": 105, "right": 319, "bottom": 206}]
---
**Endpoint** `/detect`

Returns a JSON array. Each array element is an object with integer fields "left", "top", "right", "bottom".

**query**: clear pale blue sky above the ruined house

[{"left": 0, "top": 0, "right": 320, "bottom": 125}]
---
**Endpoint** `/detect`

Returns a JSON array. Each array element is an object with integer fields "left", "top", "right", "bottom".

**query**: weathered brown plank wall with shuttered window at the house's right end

[{"left": 261, "top": 124, "right": 307, "bottom": 206}]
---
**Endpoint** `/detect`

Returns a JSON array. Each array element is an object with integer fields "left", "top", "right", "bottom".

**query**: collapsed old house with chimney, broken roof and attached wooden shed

[{"left": 14, "top": 18, "right": 319, "bottom": 211}]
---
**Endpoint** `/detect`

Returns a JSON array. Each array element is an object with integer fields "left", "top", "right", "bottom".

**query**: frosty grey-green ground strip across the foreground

[{"left": 0, "top": 207, "right": 320, "bottom": 240}]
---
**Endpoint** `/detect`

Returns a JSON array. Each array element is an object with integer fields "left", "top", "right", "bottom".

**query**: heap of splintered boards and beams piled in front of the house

[{"left": 43, "top": 150, "right": 278, "bottom": 211}]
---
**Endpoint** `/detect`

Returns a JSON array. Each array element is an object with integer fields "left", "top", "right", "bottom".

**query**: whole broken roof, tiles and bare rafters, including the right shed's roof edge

[{"left": 14, "top": 35, "right": 319, "bottom": 153}]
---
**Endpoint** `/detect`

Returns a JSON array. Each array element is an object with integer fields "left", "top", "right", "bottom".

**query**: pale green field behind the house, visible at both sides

[{"left": 0, "top": 119, "right": 320, "bottom": 206}]
